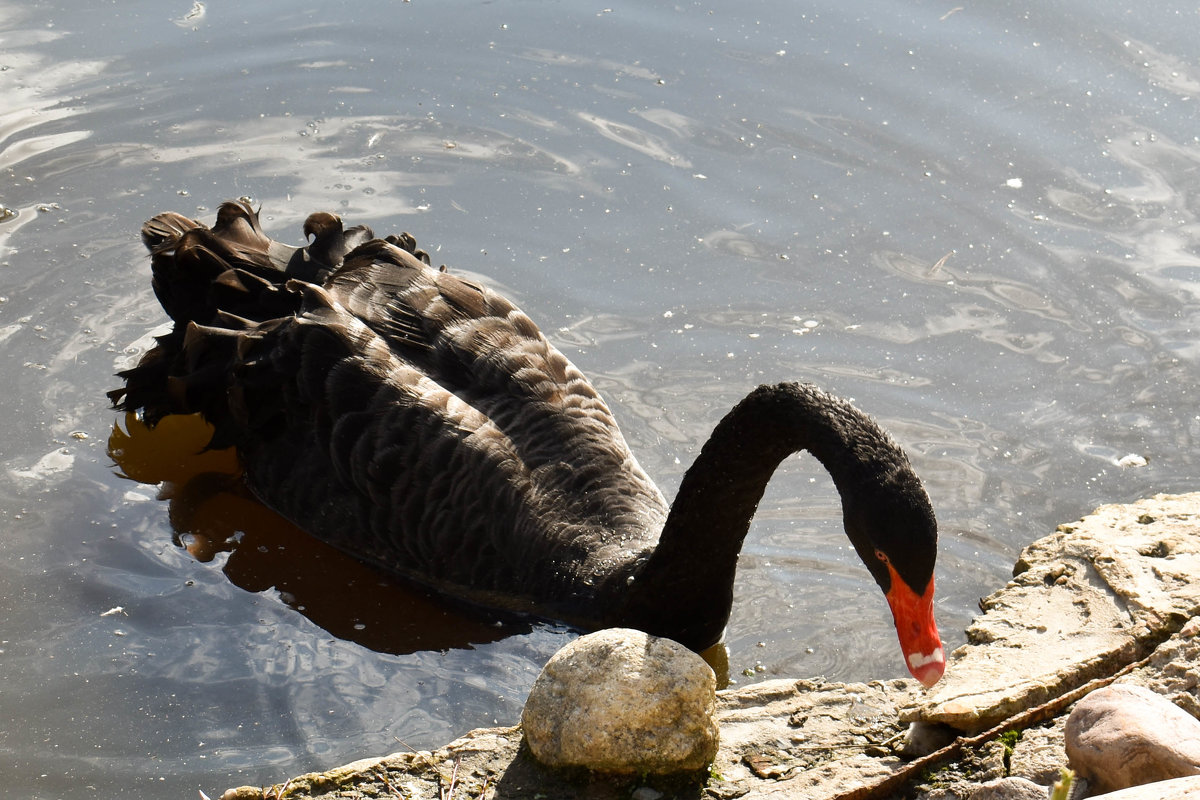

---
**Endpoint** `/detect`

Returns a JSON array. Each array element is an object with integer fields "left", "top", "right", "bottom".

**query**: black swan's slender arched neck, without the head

[{"left": 629, "top": 384, "right": 924, "bottom": 648}]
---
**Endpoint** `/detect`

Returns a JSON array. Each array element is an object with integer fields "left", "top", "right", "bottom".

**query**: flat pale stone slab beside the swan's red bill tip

[{"left": 901, "top": 494, "right": 1200, "bottom": 733}]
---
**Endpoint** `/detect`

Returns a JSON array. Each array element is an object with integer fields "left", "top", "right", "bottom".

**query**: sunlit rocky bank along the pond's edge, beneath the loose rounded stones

[{"left": 216, "top": 493, "right": 1200, "bottom": 800}]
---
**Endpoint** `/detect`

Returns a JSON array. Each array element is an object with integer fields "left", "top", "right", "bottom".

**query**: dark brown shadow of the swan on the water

[{"left": 108, "top": 414, "right": 532, "bottom": 655}]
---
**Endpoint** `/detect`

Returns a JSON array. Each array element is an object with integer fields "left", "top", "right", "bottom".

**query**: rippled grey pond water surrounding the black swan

[{"left": 0, "top": 0, "right": 1200, "bottom": 798}]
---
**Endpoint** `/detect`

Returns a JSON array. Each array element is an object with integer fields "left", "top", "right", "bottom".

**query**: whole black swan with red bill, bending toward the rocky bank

[{"left": 109, "top": 200, "right": 946, "bottom": 686}]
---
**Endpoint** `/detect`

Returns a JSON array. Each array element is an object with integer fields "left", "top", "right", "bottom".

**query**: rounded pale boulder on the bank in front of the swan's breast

[{"left": 521, "top": 628, "right": 718, "bottom": 774}]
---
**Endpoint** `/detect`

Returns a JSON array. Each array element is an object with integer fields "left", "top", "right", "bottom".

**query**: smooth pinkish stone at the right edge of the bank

[{"left": 1066, "top": 685, "right": 1200, "bottom": 792}]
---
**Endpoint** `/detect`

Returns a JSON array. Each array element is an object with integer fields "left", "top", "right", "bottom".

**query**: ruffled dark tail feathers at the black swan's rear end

[{"left": 108, "top": 200, "right": 441, "bottom": 455}]
